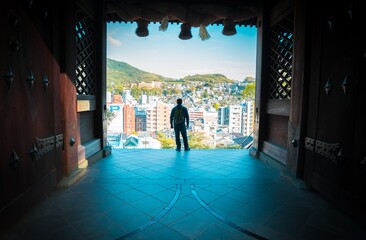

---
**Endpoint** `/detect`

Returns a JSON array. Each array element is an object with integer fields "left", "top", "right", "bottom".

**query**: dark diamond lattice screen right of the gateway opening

[{"left": 268, "top": 14, "right": 294, "bottom": 99}]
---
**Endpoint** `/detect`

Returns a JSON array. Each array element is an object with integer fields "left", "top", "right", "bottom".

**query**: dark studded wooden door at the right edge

[{"left": 304, "top": 2, "right": 366, "bottom": 223}]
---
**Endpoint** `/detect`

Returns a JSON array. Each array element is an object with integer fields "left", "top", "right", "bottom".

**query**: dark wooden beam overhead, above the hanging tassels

[{"left": 105, "top": 0, "right": 261, "bottom": 26}]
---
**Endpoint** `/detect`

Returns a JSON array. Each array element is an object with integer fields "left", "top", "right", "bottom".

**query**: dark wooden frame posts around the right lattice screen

[{"left": 250, "top": 0, "right": 309, "bottom": 178}]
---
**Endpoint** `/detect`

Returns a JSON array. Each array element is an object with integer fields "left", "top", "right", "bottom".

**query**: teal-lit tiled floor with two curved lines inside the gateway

[{"left": 4, "top": 149, "right": 366, "bottom": 240}]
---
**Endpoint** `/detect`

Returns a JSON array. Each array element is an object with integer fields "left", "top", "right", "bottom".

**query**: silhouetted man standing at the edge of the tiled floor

[{"left": 170, "top": 98, "right": 190, "bottom": 151}]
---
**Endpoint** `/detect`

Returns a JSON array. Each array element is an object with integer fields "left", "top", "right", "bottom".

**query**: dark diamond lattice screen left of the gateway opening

[{"left": 75, "top": 9, "right": 96, "bottom": 95}]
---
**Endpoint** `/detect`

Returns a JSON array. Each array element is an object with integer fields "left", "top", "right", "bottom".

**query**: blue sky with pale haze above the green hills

[{"left": 107, "top": 23, "right": 257, "bottom": 80}]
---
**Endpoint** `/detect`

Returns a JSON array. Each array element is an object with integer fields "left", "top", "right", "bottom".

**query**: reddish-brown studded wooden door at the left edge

[{"left": 0, "top": 1, "right": 62, "bottom": 230}]
